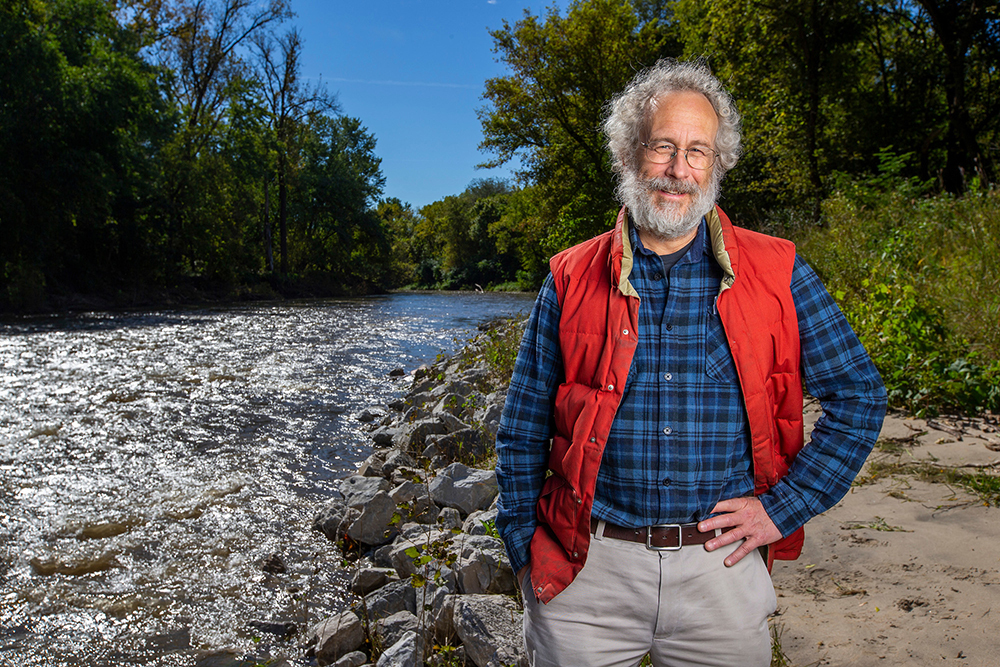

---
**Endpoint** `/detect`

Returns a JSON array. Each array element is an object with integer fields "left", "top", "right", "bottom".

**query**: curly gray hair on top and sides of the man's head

[{"left": 603, "top": 58, "right": 741, "bottom": 180}]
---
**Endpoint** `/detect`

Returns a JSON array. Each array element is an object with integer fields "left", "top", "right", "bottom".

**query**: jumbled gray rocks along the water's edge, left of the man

[{"left": 308, "top": 320, "right": 527, "bottom": 667}]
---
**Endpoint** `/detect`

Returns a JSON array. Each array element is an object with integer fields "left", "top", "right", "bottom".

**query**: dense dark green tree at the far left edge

[{"left": 0, "top": 0, "right": 171, "bottom": 307}]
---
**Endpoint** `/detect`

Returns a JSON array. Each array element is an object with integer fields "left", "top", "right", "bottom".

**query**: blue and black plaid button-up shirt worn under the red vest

[{"left": 496, "top": 223, "right": 885, "bottom": 572}]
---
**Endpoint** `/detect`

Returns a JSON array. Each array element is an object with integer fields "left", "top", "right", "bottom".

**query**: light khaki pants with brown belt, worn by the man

[{"left": 524, "top": 524, "right": 777, "bottom": 667}]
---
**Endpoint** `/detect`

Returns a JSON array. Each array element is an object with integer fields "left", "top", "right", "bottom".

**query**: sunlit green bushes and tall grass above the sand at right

[{"left": 799, "top": 183, "right": 1000, "bottom": 415}]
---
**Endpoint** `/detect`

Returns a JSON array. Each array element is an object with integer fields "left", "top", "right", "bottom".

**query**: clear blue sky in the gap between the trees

[{"left": 291, "top": 0, "right": 569, "bottom": 208}]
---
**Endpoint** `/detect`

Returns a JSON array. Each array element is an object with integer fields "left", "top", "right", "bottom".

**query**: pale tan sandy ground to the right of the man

[{"left": 772, "top": 408, "right": 1000, "bottom": 667}]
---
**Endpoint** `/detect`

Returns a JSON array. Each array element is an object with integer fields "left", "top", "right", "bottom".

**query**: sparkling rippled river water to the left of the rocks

[{"left": 0, "top": 293, "right": 531, "bottom": 667}]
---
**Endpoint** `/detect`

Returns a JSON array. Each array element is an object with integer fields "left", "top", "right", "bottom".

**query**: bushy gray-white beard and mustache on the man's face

[{"left": 618, "top": 170, "right": 722, "bottom": 239}]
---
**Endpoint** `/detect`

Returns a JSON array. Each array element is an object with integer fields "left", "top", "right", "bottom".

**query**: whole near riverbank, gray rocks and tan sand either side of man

[{"left": 309, "top": 322, "right": 1000, "bottom": 667}]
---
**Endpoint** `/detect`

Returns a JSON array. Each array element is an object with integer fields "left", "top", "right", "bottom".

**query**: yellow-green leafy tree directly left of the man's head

[{"left": 479, "top": 0, "right": 680, "bottom": 258}]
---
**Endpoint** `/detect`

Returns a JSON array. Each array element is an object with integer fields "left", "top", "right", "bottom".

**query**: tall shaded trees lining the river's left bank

[{"left": 0, "top": 0, "right": 389, "bottom": 309}]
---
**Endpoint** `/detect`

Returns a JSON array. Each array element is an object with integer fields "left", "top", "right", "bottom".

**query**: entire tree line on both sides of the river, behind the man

[{"left": 0, "top": 0, "right": 1000, "bottom": 308}]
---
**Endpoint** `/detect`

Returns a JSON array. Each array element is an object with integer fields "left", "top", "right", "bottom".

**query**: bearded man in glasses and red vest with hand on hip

[{"left": 496, "top": 61, "right": 886, "bottom": 667}]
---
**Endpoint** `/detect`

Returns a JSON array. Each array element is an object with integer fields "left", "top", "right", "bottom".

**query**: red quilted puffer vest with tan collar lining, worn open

[{"left": 531, "top": 208, "right": 803, "bottom": 602}]
